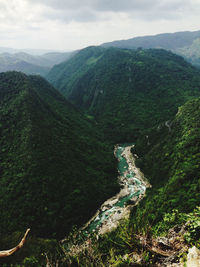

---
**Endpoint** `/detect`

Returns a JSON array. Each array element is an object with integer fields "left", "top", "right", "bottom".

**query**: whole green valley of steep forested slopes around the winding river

[{"left": 0, "top": 40, "right": 200, "bottom": 267}]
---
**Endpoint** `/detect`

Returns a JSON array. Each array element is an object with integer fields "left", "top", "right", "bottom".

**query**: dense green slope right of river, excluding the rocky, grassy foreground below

[{"left": 136, "top": 98, "right": 200, "bottom": 230}]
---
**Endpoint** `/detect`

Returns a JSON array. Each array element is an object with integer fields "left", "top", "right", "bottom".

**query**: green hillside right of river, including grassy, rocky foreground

[{"left": 66, "top": 98, "right": 200, "bottom": 266}]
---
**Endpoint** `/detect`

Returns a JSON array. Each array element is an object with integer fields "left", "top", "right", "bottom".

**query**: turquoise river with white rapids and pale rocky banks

[{"left": 82, "top": 144, "right": 150, "bottom": 235}]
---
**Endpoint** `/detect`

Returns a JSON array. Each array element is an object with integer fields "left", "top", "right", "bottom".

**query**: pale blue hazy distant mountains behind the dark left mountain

[{"left": 0, "top": 52, "right": 75, "bottom": 76}]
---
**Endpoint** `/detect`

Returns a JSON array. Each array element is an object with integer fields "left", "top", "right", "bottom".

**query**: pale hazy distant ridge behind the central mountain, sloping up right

[{"left": 102, "top": 31, "right": 200, "bottom": 66}]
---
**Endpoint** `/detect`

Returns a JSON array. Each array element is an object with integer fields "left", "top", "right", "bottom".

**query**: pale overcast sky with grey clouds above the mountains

[{"left": 0, "top": 0, "right": 200, "bottom": 50}]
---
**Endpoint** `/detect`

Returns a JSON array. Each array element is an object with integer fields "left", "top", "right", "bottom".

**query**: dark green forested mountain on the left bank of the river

[{"left": 0, "top": 72, "right": 118, "bottom": 237}]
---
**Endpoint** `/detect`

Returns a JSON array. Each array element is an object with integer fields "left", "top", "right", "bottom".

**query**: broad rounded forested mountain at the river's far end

[{"left": 47, "top": 47, "right": 200, "bottom": 143}]
